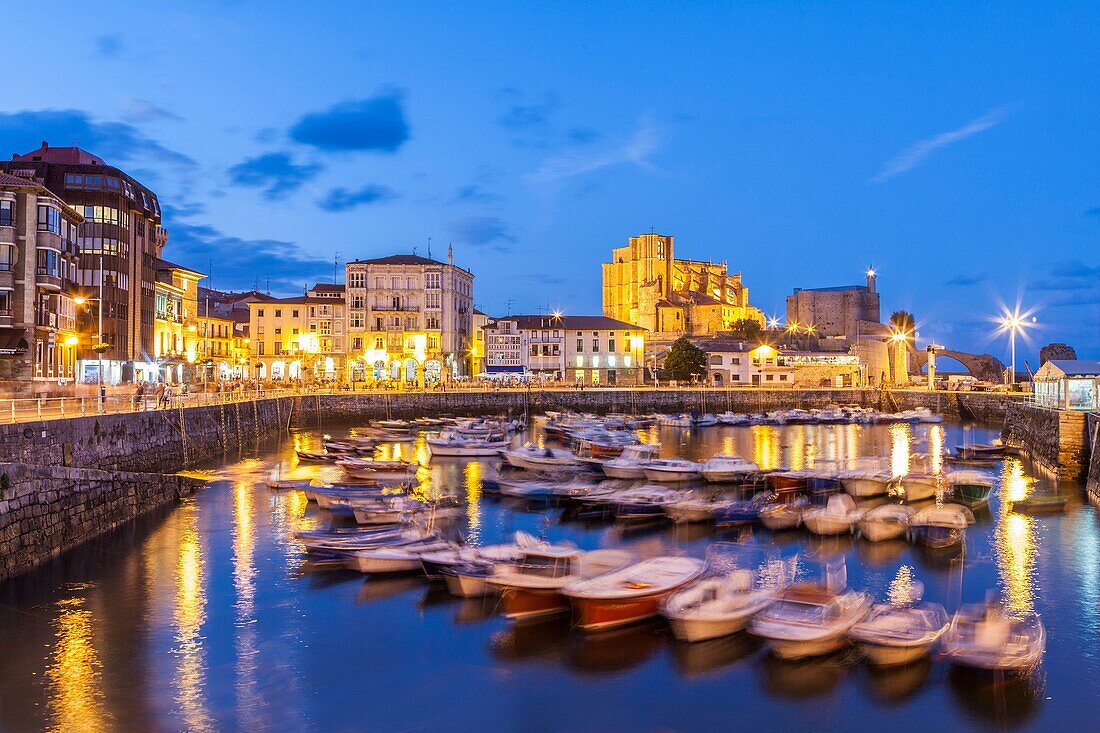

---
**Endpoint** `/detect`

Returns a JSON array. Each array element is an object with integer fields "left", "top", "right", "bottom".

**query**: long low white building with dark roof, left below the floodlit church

[{"left": 484, "top": 315, "right": 646, "bottom": 385}]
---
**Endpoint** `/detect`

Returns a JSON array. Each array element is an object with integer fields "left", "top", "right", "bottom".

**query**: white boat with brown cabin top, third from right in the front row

[{"left": 749, "top": 583, "right": 871, "bottom": 659}]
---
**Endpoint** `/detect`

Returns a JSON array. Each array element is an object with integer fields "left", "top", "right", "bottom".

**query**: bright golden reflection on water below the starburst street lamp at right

[{"left": 993, "top": 457, "right": 1038, "bottom": 615}]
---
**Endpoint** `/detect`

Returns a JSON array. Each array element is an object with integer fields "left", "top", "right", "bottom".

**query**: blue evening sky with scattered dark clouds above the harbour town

[{"left": 0, "top": 0, "right": 1100, "bottom": 368}]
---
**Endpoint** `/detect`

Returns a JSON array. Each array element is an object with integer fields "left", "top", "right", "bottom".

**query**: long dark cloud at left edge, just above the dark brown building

[{"left": 0, "top": 109, "right": 198, "bottom": 172}]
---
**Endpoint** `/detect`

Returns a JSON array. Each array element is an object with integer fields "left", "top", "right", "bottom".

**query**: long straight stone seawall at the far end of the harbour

[{"left": 292, "top": 389, "right": 1016, "bottom": 428}]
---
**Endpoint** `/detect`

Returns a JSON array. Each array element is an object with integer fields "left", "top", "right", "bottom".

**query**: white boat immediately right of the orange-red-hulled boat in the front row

[{"left": 661, "top": 543, "right": 789, "bottom": 642}]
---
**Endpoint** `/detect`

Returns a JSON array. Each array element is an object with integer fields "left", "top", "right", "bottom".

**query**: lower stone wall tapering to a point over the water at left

[{"left": 0, "top": 462, "right": 205, "bottom": 581}]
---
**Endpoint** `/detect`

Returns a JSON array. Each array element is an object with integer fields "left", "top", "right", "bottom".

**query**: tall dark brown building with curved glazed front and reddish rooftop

[{"left": 0, "top": 142, "right": 168, "bottom": 384}]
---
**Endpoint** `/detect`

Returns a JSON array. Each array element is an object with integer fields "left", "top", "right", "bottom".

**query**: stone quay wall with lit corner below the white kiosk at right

[{"left": 1001, "top": 404, "right": 1091, "bottom": 481}]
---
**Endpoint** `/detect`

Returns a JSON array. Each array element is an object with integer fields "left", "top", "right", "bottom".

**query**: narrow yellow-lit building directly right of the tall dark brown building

[{"left": 151, "top": 258, "right": 206, "bottom": 384}]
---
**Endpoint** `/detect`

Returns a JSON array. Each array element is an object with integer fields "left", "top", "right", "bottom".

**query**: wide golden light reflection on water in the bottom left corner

[{"left": 46, "top": 598, "right": 111, "bottom": 733}]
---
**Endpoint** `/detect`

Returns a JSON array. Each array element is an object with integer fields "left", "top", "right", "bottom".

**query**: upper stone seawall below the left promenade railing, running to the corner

[{"left": 0, "top": 397, "right": 295, "bottom": 472}]
